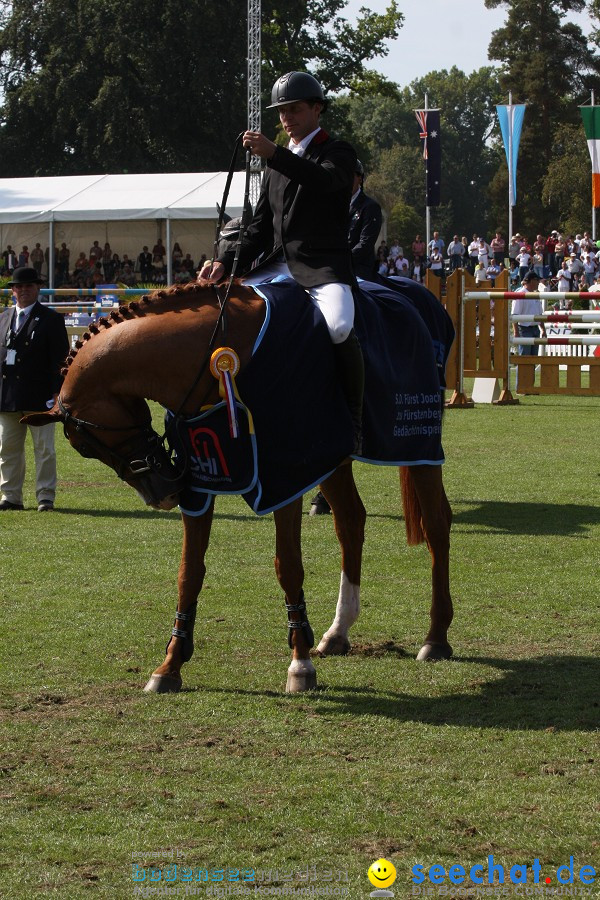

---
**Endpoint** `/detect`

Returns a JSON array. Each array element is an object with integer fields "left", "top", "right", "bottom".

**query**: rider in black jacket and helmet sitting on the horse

[{"left": 198, "top": 72, "right": 364, "bottom": 449}]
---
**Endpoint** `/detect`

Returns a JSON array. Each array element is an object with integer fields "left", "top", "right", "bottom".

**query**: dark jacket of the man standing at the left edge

[{"left": 0, "top": 302, "right": 69, "bottom": 412}]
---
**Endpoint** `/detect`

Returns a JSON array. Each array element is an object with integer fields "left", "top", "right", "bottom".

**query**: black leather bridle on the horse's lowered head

[{"left": 57, "top": 395, "right": 185, "bottom": 504}]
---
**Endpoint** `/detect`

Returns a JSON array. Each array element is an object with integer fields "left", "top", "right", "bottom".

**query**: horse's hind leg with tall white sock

[{"left": 317, "top": 463, "right": 367, "bottom": 656}]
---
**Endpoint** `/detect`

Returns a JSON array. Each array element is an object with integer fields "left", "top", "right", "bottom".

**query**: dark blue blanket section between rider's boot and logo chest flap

[{"left": 179, "top": 283, "right": 354, "bottom": 515}]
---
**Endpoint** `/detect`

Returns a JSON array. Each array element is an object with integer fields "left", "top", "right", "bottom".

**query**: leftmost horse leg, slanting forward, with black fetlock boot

[{"left": 144, "top": 498, "right": 215, "bottom": 694}]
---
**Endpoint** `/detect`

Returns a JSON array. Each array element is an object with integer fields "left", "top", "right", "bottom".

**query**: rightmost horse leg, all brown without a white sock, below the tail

[{"left": 401, "top": 466, "right": 454, "bottom": 660}]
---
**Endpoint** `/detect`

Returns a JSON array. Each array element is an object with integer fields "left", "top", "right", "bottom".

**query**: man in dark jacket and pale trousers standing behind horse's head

[{"left": 0, "top": 266, "right": 69, "bottom": 512}]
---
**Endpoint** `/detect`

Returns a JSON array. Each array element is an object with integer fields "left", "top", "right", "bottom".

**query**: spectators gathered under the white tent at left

[{"left": 0, "top": 238, "right": 206, "bottom": 288}]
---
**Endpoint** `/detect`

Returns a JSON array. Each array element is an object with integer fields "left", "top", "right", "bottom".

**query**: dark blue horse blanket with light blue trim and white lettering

[{"left": 173, "top": 282, "right": 454, "bottom": 515}]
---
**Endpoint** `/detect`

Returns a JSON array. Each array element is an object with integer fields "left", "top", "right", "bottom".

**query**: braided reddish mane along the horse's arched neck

[{"left": 61, "top": 278, "right": 252, "bottom": 376}]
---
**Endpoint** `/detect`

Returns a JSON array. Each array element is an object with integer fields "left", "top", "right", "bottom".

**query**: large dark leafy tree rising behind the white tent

[{"left": 0, "top": 0, "right": 402, "bottom": 176}]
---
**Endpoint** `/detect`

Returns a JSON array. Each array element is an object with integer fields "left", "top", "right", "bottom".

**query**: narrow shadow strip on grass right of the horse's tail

[{"left": 452, "top": 500, "right": 600, "bottom": 537}]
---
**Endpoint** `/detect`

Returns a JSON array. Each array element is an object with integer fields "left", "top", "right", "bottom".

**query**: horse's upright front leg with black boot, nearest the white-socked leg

[{"left": 274, "top": 497, "right": 317, "bottom": 694}]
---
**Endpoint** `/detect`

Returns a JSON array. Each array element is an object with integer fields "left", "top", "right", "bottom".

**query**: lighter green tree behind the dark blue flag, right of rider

[{"left": 335, "top": 67, "right": 501, "bottom": 237}]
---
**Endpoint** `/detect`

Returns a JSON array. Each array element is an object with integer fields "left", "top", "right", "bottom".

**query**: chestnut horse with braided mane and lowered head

[{"left": 27, "top": 284, "right": 452, "bottom": 693}]
